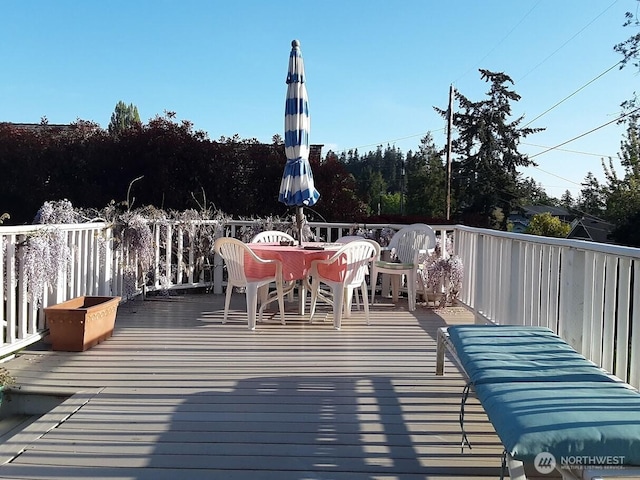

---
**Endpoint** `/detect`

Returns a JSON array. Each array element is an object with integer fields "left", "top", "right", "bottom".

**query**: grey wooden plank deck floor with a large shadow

[{"left": 0, "top": 294, "right": 536, "bottom": 480}]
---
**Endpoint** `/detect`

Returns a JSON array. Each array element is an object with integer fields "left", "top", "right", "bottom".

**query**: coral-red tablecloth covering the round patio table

[{"left": 245, "top": 243, "right": 342, "bottom": 282}]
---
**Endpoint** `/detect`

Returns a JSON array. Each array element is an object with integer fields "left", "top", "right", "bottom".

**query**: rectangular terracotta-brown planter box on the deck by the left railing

[{"left": 44, "top": 297, "right": 120, "bottom": 352}]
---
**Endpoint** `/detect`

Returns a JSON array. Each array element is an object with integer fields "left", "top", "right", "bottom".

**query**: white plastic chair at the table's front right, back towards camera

[{"left": 311, "top": 240, "right": 380, "bottom": 330}]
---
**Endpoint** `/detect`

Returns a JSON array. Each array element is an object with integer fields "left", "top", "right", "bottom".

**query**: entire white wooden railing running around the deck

[{"left": 0, "top": 221, "right": 640, "bottom": 387}]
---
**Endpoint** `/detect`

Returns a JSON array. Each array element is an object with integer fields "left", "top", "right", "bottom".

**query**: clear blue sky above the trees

[{"left": 0, "top": 0, "right": 640, "bottom": 196}]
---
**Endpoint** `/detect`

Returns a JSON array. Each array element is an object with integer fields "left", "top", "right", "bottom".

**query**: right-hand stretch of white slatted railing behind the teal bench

[{"left": 455, "top": 227, "right": 640, "bottom": 388}]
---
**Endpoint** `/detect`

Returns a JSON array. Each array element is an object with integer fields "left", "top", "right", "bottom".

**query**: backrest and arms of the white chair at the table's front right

[{"left": 317, "top": 240, "right": 380, "bottom": 286}]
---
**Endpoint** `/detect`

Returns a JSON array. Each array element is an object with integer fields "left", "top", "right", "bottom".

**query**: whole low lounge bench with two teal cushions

[{"left": 436, "top": 325, "right": 640, "bottom": 479}]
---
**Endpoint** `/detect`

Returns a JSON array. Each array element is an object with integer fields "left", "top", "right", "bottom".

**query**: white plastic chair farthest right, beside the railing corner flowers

[{"left": 371, "top": 223, "right": 436, "bottom": 311}]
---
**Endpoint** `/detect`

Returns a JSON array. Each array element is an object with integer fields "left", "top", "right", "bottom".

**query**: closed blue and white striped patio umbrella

[{"left": 278, "top": 40, "right": 320, "bottom": 245}]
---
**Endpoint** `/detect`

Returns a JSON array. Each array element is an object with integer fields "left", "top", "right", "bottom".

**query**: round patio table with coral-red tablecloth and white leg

[{"left": 247, "top": 242, "right": 344, "bottom": 315}]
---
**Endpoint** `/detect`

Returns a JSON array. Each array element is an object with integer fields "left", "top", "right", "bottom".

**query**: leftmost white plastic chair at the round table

[{"left": 214, "top": 237, "right": 285, "bottom": 330}]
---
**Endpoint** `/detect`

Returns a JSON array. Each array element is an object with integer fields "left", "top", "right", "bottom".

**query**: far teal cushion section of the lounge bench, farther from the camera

[{"left": 447, "top": 325, "right": 615, "bottom": 385}]
